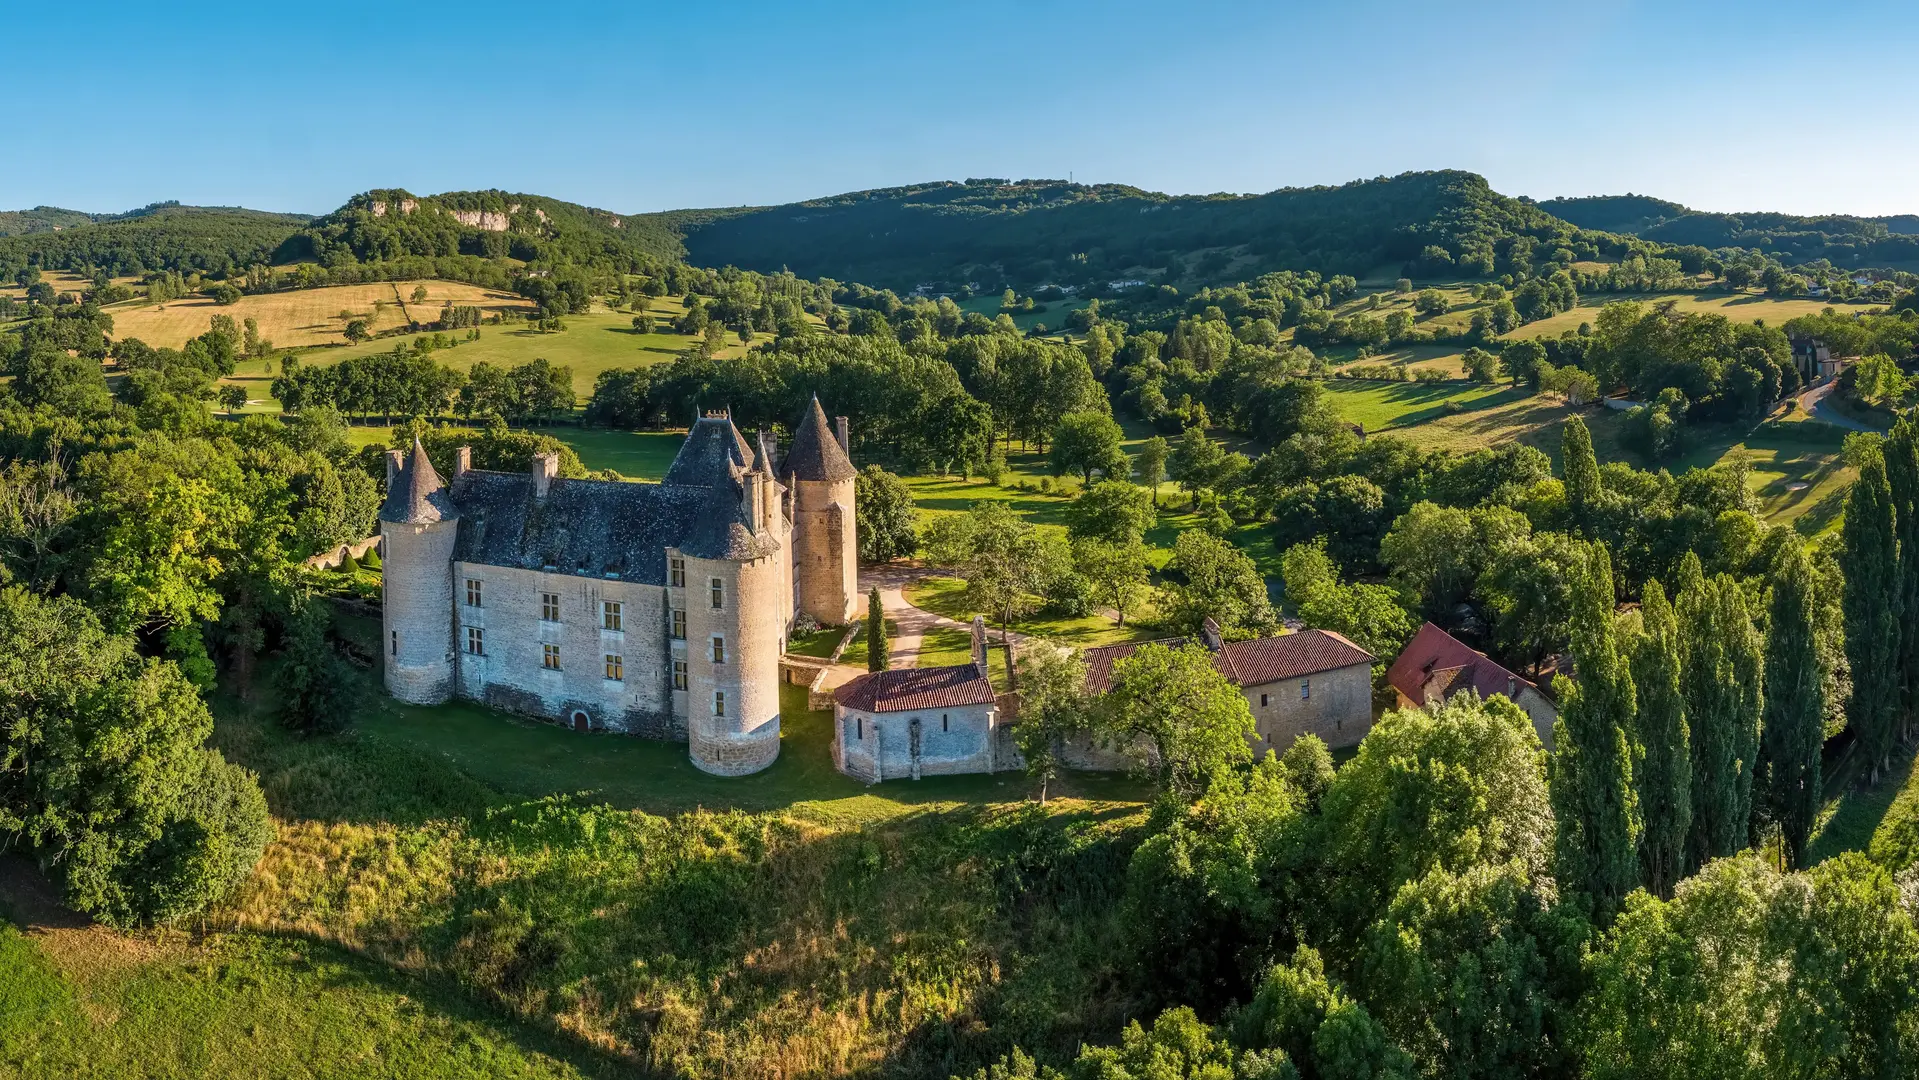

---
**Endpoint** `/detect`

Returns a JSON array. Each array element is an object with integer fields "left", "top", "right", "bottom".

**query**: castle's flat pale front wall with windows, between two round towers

[{"left": 451, "top": 562, "right": 685, "bottom": 739}]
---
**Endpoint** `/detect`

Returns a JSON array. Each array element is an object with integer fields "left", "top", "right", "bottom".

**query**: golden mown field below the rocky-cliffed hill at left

[{"left": 107, "top": 282, "right": 532, "bottom": 349}]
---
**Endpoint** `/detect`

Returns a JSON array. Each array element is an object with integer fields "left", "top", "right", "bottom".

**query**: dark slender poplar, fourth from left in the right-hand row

[{"left": 1756, "top": 541, "right": 1825, "bottom": 865}]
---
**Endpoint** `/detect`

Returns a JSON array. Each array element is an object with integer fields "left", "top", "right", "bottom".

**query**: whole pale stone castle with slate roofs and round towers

[{"left": 380, "top": 405, "right": 856, "bottom": 775}]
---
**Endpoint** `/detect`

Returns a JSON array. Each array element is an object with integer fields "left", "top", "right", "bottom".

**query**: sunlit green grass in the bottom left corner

[{"left": 0, "top": 913, "right": 626, "bottom": 1080}]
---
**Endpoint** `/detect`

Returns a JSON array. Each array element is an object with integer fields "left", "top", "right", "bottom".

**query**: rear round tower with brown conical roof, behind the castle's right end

[{"left": 781, "top": 397, "right": 860, "bottom": 623}]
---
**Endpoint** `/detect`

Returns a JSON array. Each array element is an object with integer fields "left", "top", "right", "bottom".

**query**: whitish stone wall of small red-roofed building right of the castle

[{"left": 833, "top": 704, "right": 998, "bottom": 783}]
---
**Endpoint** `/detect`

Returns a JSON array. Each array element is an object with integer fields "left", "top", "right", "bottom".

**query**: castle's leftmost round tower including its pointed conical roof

[{"left": 380, "top": 439, "right": 459, "bottom": 704}]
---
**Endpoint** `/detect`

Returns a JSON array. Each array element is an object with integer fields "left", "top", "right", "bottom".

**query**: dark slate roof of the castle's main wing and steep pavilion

[{"left": 445, "top": 416, "right": 779, "bottom": 585}]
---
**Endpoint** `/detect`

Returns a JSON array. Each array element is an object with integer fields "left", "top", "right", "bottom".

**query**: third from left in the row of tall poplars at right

[{"left": 1679, "top": 552, "right": 1765, "bottom": 869}]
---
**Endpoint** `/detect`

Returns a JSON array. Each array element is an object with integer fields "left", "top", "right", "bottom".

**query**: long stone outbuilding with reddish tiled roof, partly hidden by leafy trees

[{"left": 1069, "top": 620, "right": 1374, "bottom": 755}]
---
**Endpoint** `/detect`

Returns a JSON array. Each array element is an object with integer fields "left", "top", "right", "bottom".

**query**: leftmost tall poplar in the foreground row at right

[{"left": 1551, "top": 545, "right": 1639, "bottom": 923}]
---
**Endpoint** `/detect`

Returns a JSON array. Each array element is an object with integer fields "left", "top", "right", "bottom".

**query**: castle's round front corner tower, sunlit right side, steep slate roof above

[{"left": 666, "top": 416, "right": 787, "bottom": 777}]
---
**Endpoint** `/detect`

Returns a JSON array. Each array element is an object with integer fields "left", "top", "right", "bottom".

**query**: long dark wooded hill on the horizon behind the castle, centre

[{"left": 647, "top": 171, "right": 1572, "bottom": 290}]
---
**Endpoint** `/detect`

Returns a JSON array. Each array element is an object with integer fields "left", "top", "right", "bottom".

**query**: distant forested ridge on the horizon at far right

[{"left": 1539, "top": 194, "right": 1919, "bottom": 267}]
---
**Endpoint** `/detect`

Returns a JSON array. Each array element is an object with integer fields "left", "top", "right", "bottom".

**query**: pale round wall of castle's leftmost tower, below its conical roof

[{"left": 380, "top": 522, "right": 459, "bottom": 704}]
